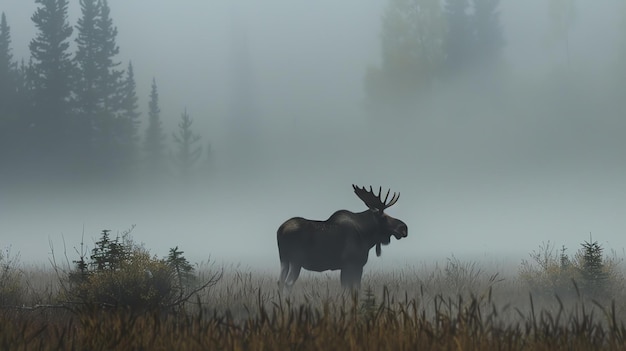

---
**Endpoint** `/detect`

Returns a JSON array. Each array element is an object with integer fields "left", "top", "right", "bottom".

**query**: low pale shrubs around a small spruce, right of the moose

[{"left": 519, "top": 240, "right": 624, "bottom": 297}]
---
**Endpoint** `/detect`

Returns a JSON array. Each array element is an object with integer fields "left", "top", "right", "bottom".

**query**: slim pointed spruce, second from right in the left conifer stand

[{"left": 143, "top": 78, "right": 165, "bottom": 172}]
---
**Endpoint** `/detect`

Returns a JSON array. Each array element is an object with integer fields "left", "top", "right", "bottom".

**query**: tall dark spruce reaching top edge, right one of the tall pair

[{"left": 75, "top": 0, "right": 127, "bottom": 173}]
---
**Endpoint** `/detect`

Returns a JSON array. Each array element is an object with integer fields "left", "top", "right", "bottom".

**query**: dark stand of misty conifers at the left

[{"left": 0, "top": 0, "right": 202, "bottom": 186}]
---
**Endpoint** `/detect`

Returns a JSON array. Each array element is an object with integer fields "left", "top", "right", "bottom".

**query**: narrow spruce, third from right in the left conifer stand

[{"left": 117, "top": 62, "right": 141, "bottom": 170}]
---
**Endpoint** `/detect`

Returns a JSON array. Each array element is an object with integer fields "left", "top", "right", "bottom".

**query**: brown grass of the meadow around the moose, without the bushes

[{"left": 0, "top": 253, "right": 626, "bottom": 350}]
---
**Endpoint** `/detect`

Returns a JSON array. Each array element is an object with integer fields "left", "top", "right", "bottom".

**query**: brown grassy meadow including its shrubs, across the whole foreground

[{"left": 0, "top": 231, "right": 626, "bottom": 350}]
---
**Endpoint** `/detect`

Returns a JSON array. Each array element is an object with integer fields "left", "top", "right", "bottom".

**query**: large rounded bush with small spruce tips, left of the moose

[{"left": 64, "top": 230, "right": 201, "bottom": 311}]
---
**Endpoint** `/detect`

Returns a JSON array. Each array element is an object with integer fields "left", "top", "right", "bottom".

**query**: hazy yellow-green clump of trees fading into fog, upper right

[{"left": 365, "top": 0, "right": 505, "bottom": 110}]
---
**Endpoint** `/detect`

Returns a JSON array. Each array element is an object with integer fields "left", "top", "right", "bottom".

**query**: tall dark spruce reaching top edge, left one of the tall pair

[{"left": 28, "top": 0, "right": 74, "bottom": 168}]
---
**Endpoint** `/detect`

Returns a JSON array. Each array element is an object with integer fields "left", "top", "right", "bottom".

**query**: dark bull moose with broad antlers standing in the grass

[{"left": 276, "top": 184, "right": 408, "bottom": 289}]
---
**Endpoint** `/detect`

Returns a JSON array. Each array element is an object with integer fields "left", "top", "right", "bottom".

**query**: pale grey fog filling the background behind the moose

[{"left": 0, "top": 0, "right": 626, "bottom": 271}]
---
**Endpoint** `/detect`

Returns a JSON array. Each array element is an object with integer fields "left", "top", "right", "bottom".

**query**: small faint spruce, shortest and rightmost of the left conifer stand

[{"left": 172, "top": 109, "right": 202, "bottom": 176}]
